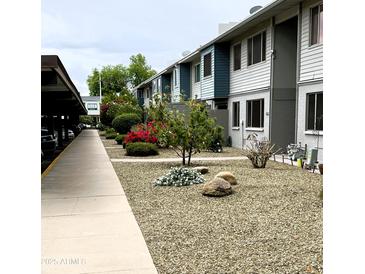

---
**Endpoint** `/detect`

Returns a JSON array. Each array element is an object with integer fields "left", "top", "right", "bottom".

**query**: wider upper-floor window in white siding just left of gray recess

[{"left": 247, "top": 31, "right": 266, "bottom": 66}]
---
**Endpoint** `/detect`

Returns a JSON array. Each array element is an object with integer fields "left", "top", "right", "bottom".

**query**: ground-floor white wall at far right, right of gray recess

[{"left": 297, "top": 83, "right": 323, "bottom": 162}]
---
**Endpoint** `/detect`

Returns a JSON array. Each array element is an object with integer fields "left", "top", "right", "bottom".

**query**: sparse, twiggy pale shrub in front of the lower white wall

[{"left": 243, "top": 133, "right": 275, "bottom": 168}]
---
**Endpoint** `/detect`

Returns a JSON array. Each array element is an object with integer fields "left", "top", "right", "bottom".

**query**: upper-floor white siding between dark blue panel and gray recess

[{"left": 230, "top": 26, "right": 271, "bottom": 94}]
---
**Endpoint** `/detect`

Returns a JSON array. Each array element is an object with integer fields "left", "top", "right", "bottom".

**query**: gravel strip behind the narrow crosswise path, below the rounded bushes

[{"left": 100, "top": 136, "right": 243, "bottom": 159}]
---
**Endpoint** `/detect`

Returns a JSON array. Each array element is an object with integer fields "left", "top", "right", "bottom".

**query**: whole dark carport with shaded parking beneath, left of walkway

[{"left": 41, "top": 55, "right": 87, "bottom": 147}]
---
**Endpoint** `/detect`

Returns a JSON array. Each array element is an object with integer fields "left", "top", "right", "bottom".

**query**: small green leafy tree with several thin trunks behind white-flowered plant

[{"left": 167, "top": 100, "right": 216, "bottom": 165}]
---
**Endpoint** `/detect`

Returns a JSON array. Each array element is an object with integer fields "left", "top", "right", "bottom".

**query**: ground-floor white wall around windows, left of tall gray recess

[{"left": 228, "top": 90, "right": 270, "bottom": 148}]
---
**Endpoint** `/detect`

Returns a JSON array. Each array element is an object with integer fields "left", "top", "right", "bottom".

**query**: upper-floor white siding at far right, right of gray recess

[{"left": 300, "top": 1, "right": 323, "bottom": 81}]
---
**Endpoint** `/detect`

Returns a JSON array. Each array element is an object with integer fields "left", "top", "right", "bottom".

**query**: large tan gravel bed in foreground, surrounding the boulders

[{"left": 108, "top": 158, "right": 322, "bottom": 274}]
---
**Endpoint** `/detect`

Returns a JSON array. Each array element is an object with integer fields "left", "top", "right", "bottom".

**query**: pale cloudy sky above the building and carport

[{"left": 41, "top": 0, "right": 272, "bottom": 95}]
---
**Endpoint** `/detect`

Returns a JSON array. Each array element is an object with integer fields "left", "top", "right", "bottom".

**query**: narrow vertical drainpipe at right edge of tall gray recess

[{"left": 294, "top": 2, "right": 303, "bottom": 143}]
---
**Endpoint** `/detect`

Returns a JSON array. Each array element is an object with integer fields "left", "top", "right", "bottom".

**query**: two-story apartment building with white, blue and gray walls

[{"left": 132, "top": 0, "right": 323, "bottom": 161}]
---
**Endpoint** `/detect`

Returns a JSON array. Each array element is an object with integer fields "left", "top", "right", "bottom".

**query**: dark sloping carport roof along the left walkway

[{"left": 41, "top": 55, "right": 87, "bottom": 115}]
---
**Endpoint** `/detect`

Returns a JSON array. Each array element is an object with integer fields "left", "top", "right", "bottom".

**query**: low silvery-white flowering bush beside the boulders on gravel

[{"left": 153, "top": 167, "right": 204, "bottom": 186}]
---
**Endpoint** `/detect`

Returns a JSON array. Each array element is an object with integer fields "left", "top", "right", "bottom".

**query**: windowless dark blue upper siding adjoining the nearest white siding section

[{"left": 214, "top": 44, "right": 230, "bottom": 98}]
